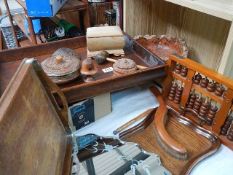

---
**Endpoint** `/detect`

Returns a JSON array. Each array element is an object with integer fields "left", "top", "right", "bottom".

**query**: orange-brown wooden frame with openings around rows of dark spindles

[{"left": 163, "top": 56, "right": 233, "bottom": 149}]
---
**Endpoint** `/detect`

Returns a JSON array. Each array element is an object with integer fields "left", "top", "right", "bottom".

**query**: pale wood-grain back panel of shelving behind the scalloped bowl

[{"left": 124, "top": 0, "right": 231, "bottom": 70}]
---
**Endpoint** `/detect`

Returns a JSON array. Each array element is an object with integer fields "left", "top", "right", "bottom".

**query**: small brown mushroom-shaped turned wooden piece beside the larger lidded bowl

[{"left": 80, "top": 58, "right": 97, "bottom": 82}]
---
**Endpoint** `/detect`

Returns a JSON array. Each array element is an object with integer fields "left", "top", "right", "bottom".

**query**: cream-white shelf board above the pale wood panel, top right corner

[{"left": 165, "top": 0, "right": 233, "bottom": 21}]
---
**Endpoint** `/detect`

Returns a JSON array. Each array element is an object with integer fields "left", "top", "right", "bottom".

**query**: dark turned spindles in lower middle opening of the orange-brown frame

[{"left": 186, "top": 93, "right": 218, "bottom": 125}]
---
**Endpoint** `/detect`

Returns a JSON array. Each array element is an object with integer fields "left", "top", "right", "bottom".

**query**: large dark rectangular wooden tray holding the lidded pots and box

[{"left": 0, "top": 35, "right": 165, "bottom": 104}]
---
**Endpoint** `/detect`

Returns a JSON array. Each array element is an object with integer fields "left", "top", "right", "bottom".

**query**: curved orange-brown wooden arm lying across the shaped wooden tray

[{"left": 150, "top": 87, "right": 188, "bottom": 159}]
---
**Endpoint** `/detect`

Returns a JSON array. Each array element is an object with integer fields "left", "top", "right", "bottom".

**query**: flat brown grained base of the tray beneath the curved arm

[{"left": 123, "top": 111, "right": 219, "bottom": 175}]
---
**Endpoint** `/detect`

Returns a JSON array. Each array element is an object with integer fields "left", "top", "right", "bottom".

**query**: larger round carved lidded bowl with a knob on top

[{"left": 41, "top": 48, "right": 81, "bottom": 83}]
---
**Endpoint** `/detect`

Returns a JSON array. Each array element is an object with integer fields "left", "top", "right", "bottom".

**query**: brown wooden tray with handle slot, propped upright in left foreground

[{"left": 0, "top": 59, "right": 73, "bottom": 175}]
